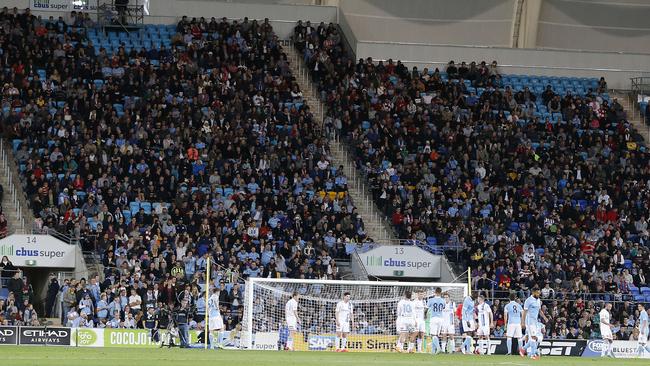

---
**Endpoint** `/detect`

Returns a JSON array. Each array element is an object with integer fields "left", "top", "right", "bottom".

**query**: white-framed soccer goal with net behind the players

[{"left": 242, "top": 278, "right": 468, "bottom": 352}]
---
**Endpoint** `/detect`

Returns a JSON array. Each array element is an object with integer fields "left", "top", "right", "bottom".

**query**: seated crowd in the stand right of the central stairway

[{"left": 293, "top": 22, "right": 650, "bottom": 340}]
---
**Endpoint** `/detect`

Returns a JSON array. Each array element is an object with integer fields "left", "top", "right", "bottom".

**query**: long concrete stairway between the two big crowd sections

[{"left": 284, "top": 43, "right": 396, "bottom": 243}]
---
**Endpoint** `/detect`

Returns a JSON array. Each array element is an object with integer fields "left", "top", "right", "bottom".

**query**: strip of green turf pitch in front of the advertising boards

[{"left": 0, "top": 346, "right": 648, "bottom": 366}]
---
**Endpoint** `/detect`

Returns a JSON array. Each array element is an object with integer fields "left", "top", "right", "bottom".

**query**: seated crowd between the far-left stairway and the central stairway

[{"left": 0, "top": 8, "right": 369, "bottom": 326}]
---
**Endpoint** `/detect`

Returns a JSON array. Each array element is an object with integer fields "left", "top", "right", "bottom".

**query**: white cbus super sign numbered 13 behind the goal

[{"left": 357, "top": 245, "right": 442, "bottom": 278}]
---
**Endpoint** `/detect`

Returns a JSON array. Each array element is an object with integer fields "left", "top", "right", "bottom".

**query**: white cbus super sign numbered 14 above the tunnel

[{"left": 0, "top": 234, "right": 76, "bottom": 268}]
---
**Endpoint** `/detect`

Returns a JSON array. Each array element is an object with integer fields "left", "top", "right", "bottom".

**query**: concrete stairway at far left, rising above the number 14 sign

[{"left": 0, "top": 138, "right": 33, "bottom": 234}]
